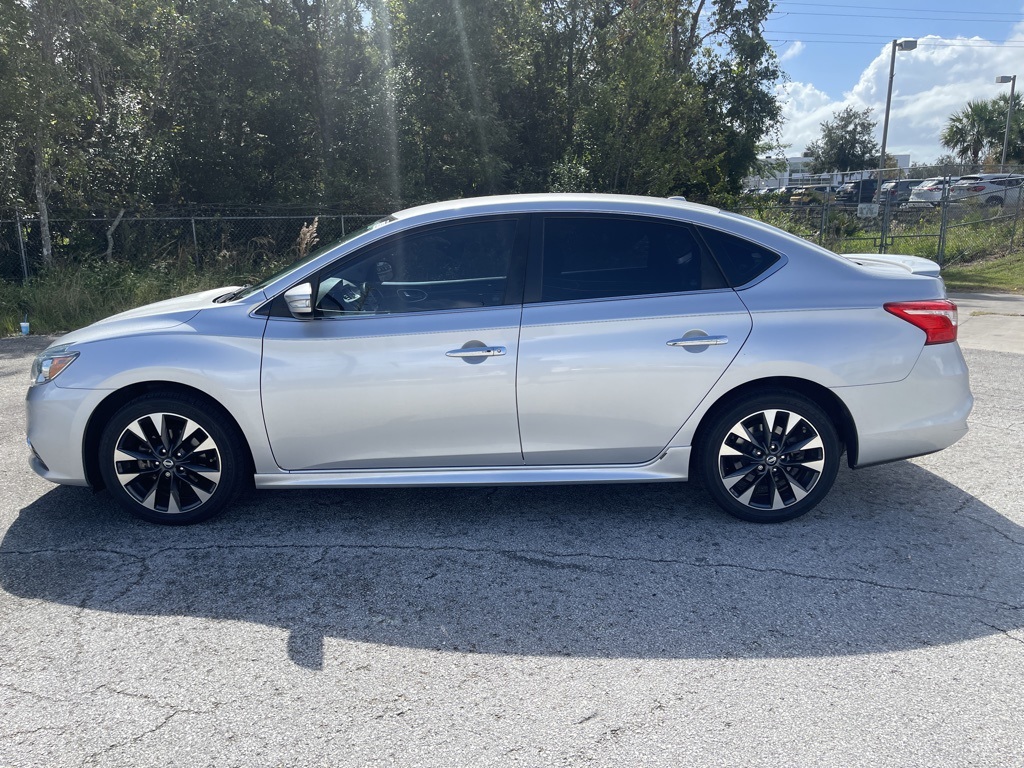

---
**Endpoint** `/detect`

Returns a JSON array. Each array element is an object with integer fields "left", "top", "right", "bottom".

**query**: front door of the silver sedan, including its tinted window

[{"left": 261, "top": 217, "right": 526, "bottom": 471}]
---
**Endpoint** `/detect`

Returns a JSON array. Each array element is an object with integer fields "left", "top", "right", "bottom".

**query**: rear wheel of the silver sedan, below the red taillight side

[{"left": 696, "top": 390, "right": 842, "bottom": 522}]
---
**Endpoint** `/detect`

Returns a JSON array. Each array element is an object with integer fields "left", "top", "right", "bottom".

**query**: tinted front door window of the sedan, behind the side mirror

[{"left": 316, "top": 219, "right": 517, "bottom": 316}]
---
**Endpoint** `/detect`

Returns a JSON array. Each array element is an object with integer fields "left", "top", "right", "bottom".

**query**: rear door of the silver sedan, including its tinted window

[{"left": 518, "top": 214, "right": 751, "bottom": 465}]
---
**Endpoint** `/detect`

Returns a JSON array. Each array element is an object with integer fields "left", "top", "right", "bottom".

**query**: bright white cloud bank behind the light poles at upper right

[{"left": 776, "top": 34, "right": 1024, "bottom": 163}]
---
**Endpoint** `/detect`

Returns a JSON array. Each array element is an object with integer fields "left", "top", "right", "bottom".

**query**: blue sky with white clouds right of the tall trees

[{"left": 764, "top": 0, "right": 1024, "bottom": 163}]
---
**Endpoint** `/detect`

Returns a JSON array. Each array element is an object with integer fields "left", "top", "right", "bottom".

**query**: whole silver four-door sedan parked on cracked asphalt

[{"left": 22, "top": 195, "right": 973, "bottom": 523}]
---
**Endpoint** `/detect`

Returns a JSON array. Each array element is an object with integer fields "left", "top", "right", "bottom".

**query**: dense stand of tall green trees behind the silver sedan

[{"left": 0, "top": 0, "right": 779, "bottom": 237}]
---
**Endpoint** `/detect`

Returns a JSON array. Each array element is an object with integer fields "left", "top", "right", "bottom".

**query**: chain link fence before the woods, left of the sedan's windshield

[{"left": 0, "top": 211, "right": 381, "bottom": 282}]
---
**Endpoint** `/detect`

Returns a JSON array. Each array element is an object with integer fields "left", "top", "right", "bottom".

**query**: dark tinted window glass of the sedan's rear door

[{"left": 540, "top": 216, "right": 725, "bottom": 301}]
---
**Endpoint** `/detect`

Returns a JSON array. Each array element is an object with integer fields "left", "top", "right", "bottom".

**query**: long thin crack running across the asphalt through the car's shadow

[{"left": 0, "top": 540, "right": 1024, "bottom": 610}]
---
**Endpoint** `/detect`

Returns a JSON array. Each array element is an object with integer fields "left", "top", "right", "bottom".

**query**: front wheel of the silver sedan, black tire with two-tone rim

[{"left": 99, "top": 393, "right": 247, "bottom": 525}]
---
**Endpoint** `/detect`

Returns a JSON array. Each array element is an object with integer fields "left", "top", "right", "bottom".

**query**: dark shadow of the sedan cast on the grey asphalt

[{"left": 0, "top": 462, "right": 1024, "bottom": 669}]
